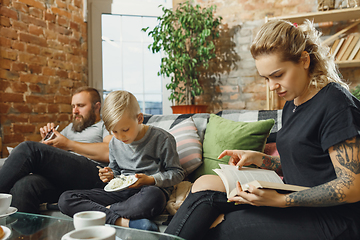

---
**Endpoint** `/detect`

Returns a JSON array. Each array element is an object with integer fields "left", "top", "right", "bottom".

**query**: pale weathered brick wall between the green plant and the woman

[{"left": 184, "top": 0, "right": 360, "bottom": 112}]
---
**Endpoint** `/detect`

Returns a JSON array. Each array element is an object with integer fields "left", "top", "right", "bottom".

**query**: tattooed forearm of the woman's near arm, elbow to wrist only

[{"left": 286, "top": 167, "right": 355, "bottom": 207}]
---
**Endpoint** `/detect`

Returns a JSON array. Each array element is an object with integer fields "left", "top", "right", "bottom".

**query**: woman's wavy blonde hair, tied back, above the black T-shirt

[{"left": 250, "top": 20, "right": 349, "bottom": 89}]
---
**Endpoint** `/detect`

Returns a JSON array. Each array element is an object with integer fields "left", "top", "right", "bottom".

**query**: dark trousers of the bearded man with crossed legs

[{"left": 0, "top": 141, "right": 104, "bottom": 213}]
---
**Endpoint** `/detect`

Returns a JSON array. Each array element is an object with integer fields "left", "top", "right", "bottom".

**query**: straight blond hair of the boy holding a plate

[{"left": 101, "top": 90, "right": 141, "bottom": 131}]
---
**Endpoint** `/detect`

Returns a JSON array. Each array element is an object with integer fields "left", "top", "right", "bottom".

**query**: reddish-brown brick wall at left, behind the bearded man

[{"left": 0, "top": 0, "right": 88, "bottom": 157}]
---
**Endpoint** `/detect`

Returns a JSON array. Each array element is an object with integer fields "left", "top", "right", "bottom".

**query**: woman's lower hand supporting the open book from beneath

[{"left": 228, "top": 182, "right": 286, "bottom": 207}]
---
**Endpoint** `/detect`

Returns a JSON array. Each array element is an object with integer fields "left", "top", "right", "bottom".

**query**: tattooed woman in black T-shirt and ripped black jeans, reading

[{"left": 166, "top": 20, "right": 360, "bottom": 240}]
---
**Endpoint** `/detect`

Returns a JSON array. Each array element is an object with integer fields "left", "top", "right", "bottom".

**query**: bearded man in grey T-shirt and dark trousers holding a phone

[{"left": 0, "top": 87, "right": 112, "bottom": 213}]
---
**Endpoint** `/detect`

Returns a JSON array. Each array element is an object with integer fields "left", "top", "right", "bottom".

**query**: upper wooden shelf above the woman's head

[{"left": 268, "top": 7, "right": 360, "bottom": 24}]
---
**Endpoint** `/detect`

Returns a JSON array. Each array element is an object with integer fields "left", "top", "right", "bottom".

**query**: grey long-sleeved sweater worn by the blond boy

[{"left": 109, "top": 126, "right": 185, "bottom": 188}]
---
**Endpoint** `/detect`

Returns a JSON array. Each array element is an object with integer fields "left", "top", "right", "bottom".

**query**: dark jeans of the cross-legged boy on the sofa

[{"left": 58, "top": 186, "right": 167, "bottom": 225}]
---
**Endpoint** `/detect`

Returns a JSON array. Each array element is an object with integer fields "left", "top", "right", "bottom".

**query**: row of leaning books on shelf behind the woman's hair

[{"left": 330, "top": 33, "right": 360, "bottom": 62}]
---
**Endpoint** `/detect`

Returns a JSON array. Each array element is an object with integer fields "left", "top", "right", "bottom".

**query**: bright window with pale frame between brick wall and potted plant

[{"left": 88, "top": 0, "right": 172, "bottom": 114}]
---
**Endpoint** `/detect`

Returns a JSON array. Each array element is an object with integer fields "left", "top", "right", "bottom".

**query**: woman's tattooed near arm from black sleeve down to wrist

[{"left": 286, "top": 137, "right": 360, "bottom": 207}]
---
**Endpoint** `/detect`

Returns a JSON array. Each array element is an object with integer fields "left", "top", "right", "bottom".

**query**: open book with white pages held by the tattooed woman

[{"left": 213, "top": 164, "right": 308, "bottom": 198}]
